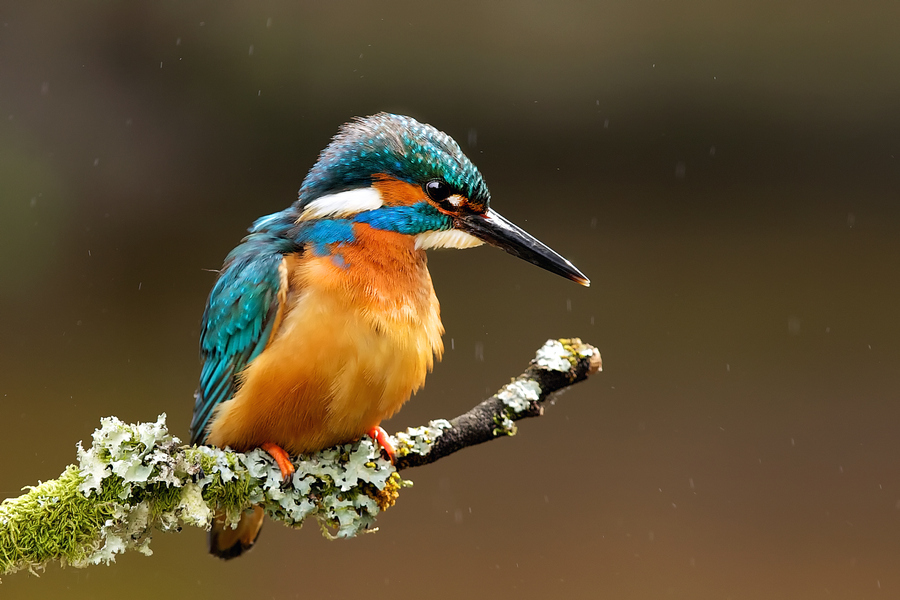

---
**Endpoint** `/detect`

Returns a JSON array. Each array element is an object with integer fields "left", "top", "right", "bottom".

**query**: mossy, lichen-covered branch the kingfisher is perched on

[{"left": 0, "top": 339, "right": 601, "bottom": 574}]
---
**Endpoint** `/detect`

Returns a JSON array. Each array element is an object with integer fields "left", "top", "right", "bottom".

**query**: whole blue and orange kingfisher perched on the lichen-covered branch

[{"left": 190, "top": 112, "right": 590, "bottom": 559}]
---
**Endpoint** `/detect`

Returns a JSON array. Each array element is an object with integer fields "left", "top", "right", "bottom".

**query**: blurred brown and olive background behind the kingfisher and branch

[{"left": 0, "top": 0, "right": 900, "bottom": 600}]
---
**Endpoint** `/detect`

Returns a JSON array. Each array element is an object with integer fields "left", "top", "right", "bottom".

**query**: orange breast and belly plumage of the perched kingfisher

[{"left": 208, "top": 224, "right": 443, "bottom": 454}]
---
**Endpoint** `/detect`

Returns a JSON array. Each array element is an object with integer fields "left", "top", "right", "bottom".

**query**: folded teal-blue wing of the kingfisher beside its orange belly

[{"left": 191, "top": 246, "right": 287, "bottom": 444}]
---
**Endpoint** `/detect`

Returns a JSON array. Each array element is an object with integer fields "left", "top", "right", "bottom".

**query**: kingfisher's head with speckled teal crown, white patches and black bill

[{"left": 294, "top": 113, "right": 590, "bottom": 286}]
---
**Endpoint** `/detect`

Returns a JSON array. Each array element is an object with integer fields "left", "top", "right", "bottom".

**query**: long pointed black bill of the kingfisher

[{"left": 456, "top": 208, "right": 591, "bottom": 287}]
